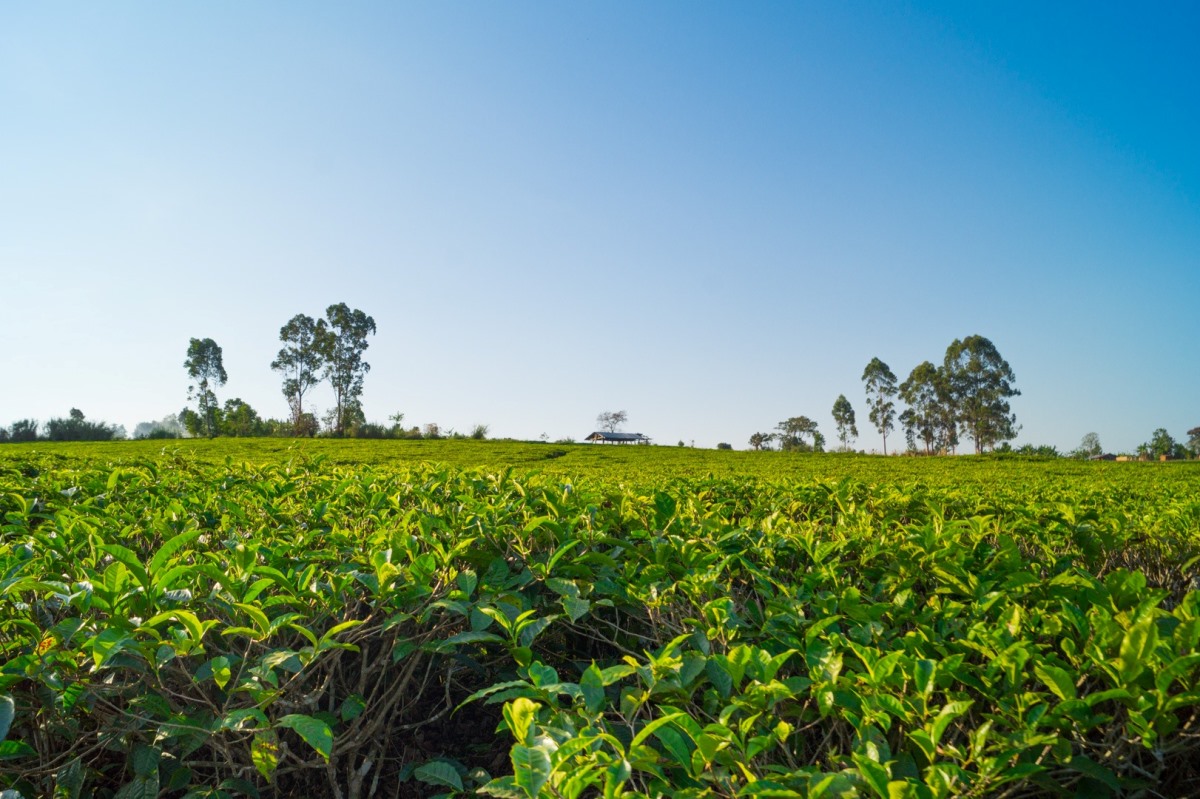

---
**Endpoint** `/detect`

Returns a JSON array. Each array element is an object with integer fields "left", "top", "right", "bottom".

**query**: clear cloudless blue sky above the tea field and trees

[{"left": 0, "top": 0, "right": 1200, "bottom": 452}]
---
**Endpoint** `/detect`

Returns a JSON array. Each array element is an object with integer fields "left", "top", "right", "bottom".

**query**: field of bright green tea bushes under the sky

[{"left": 0, "top": 439, "right": 1200, "bottom": 799}]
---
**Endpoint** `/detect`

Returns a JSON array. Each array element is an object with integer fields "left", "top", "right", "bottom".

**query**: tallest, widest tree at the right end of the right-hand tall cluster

[{"left": 943, "top": 336, "right": 1021, "bottom": 455}]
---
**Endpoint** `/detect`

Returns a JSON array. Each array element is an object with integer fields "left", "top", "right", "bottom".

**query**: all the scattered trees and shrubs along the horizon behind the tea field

[{"left": 0, "top": 323, "right": 1200, "bottom": 457}]
